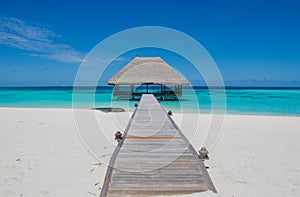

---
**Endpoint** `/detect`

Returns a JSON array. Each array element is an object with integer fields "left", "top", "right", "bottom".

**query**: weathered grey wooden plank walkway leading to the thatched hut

[{"left": 100, "top": 94, "right": 216, "bottom": 197}]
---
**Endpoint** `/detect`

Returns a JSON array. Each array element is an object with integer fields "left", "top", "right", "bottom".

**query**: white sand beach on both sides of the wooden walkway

[{"left": 0, "top": 108, "right": 300, "bottom": 197}]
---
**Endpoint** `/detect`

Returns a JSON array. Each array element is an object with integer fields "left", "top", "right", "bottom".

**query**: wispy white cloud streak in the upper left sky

[{"left": 0, "top": 17, "right": 85, "bottom": 63}]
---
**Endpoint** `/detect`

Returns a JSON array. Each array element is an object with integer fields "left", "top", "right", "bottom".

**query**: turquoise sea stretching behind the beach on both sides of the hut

[{"left": 0, "top": 87, "right": 300, "bottom": 116}]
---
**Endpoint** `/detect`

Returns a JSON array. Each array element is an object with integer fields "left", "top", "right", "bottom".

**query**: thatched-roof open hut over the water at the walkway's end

[{"left": 108, "top": 57, "right": 189, "bottom": 99}]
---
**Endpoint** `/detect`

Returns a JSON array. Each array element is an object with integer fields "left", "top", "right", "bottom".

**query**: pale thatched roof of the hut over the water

[{"left": 108, "top": 57, "right": 189, "bottom": 85}]
